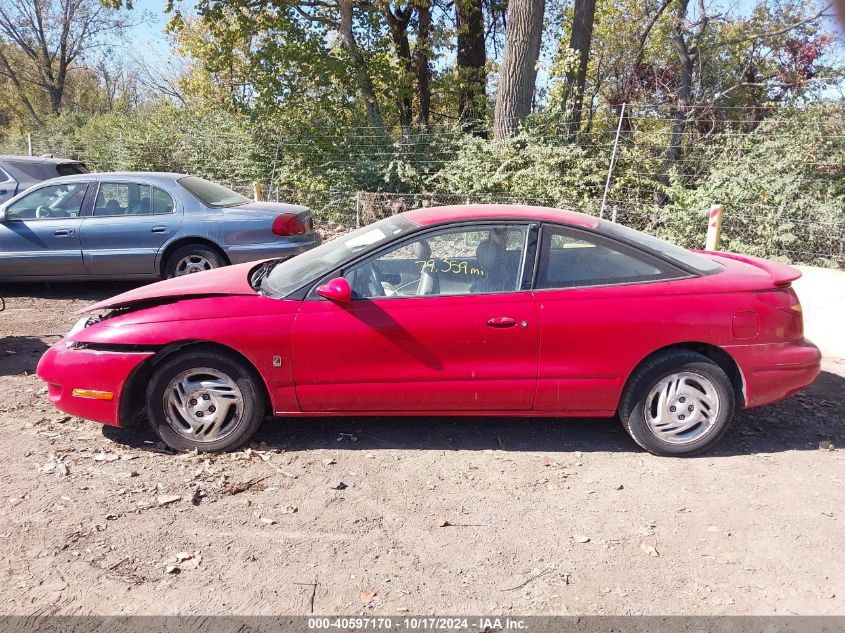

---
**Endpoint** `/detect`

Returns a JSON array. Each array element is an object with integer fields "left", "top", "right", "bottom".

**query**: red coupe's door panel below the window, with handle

[{"left": 293, "top": 292, "right": 539, "bottom": 412}]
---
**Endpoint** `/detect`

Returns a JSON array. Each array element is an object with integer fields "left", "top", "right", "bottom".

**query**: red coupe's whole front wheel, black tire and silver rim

[{"left": 147, "top": 349, "right": 267, "bottom": 451}]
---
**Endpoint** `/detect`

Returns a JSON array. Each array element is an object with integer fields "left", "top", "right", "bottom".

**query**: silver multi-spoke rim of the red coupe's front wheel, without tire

[{"left": 163, "top": 367, "right": 244, "bottom": 442}]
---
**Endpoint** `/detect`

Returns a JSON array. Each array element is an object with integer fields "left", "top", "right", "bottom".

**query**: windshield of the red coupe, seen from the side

[{"left": 261, "top": 215, "right": 419, "bottom": 297}]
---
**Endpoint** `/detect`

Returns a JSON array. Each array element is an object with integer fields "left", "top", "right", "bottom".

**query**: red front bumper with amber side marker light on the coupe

[{"left": 36, "top": 339, "right": 153, "bottom": 426}]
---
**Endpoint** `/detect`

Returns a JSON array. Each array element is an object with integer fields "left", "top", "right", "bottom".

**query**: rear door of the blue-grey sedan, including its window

[{"left": 81, "top": 181, "right": 182, "bottom": 276}]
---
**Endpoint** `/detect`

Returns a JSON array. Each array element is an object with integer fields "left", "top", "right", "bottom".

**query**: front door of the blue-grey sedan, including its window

[{"left": 0, "top": 182, "right": 89, "bottom": 278}]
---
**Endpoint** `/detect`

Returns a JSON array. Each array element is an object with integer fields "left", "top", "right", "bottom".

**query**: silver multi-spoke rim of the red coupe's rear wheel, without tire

[{"left": 643, "top": 371, "right": 719, "bottom": 444}]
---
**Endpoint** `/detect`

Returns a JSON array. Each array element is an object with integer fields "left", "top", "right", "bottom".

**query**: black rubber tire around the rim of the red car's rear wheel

[{"left": 619, "top": 350, "right": 736, "bottom": 456}]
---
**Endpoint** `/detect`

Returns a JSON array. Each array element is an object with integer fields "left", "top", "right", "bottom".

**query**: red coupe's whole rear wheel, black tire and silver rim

[{"left": 619, "top": 350, "right": 735, "bottom": 455}]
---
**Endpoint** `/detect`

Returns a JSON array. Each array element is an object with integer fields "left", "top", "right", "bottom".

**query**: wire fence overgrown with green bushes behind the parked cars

[{"left": 0, "top": 104, "right": 845, "bottom": 268}]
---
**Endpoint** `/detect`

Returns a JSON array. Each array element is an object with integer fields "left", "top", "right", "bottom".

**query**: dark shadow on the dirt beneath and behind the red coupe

[{"left": 103, "top": 372, "right": 845, "bottom": 458}]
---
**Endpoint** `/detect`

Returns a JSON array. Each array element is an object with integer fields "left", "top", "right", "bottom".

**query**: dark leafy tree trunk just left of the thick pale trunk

[{"left": 455, "top": 0, "right": 487, "bottom": 128}]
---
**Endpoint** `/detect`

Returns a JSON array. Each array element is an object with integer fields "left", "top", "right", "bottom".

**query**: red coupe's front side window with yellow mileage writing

[{"left": 343, "top": 225, "right": 528, "bottom": 299}]
